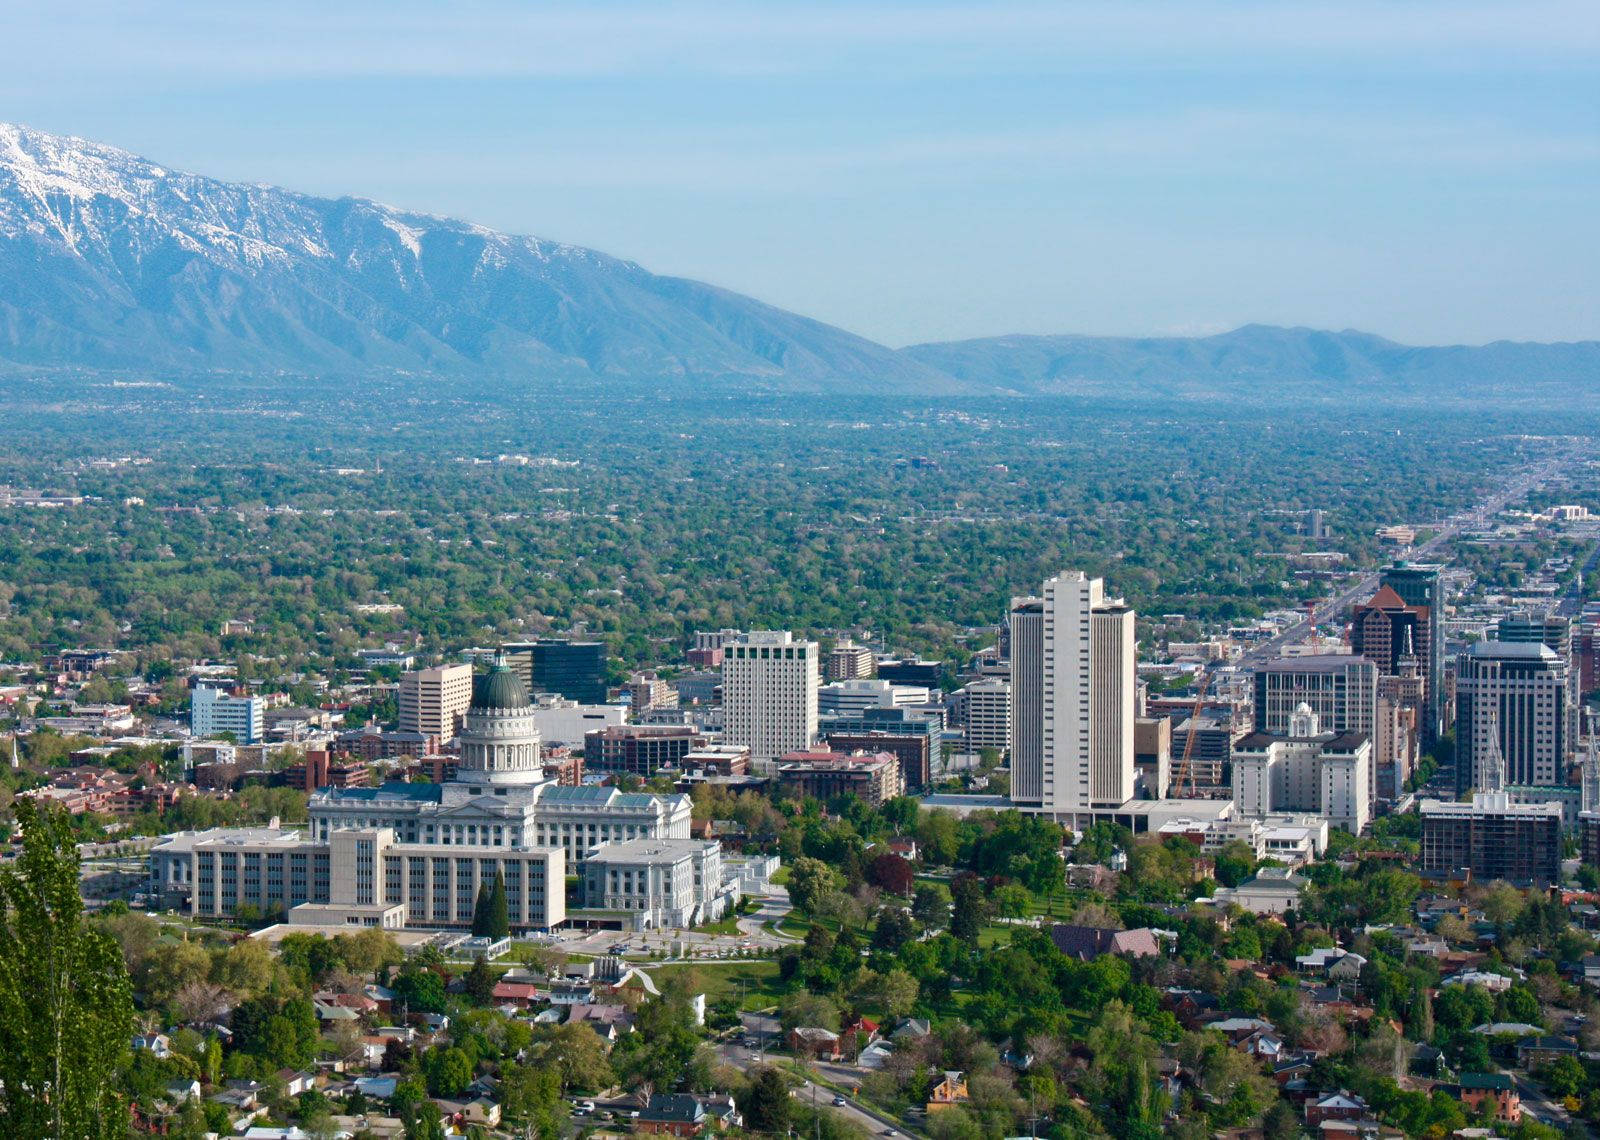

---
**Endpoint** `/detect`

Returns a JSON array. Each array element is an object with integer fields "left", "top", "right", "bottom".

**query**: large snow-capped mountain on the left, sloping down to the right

[{"left": 0, "top": 123, "right": 965, "bottom": 391}]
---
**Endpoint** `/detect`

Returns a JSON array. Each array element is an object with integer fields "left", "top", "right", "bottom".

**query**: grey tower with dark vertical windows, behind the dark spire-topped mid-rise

[{"left": 1456, "top": 642, "right": 1573, "bottom": 794}]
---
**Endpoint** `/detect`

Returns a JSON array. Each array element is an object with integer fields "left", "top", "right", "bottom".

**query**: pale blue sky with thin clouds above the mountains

[{"left": 0, "top": 0, "right": 1600, "bottom": 346}]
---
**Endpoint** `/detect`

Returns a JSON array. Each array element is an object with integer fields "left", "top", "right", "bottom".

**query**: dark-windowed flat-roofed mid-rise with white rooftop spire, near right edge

[{"left": 1419, "top": 791, "right": 1562, "bottom": 887}]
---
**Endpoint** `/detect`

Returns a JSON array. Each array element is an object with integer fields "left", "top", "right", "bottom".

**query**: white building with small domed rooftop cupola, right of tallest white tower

[{"left": 1232, "top": 704, "right": 1373, "bottom": 834}]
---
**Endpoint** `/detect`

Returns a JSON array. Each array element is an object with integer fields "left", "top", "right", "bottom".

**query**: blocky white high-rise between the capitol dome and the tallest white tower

[{"left": 722, "top": 629, "right": 821, "bottom": 765}]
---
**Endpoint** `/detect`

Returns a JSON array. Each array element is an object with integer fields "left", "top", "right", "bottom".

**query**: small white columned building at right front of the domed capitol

[{"left": 582, "top": 839, "right": 739, "bottom": 930}]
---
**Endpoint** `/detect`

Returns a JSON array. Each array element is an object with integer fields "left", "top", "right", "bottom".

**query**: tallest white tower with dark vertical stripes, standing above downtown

[{"left": 1011, "top": 572, "right": 1136, "bottom": 817}]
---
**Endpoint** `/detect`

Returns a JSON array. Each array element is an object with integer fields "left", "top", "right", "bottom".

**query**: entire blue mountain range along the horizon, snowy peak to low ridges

[{"left": 0, "top": 123, "right": 1600, "bottom": 397}]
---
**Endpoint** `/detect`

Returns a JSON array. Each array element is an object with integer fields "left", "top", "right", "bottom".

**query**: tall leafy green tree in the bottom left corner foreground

[{"left": 0, "top": 799, "right": 133, "bottom": 1140}]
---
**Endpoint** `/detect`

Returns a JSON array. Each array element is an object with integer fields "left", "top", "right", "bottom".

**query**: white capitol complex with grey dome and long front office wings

[{"left": 150, "top": 661, "right": 738, "bottom": 930}]
